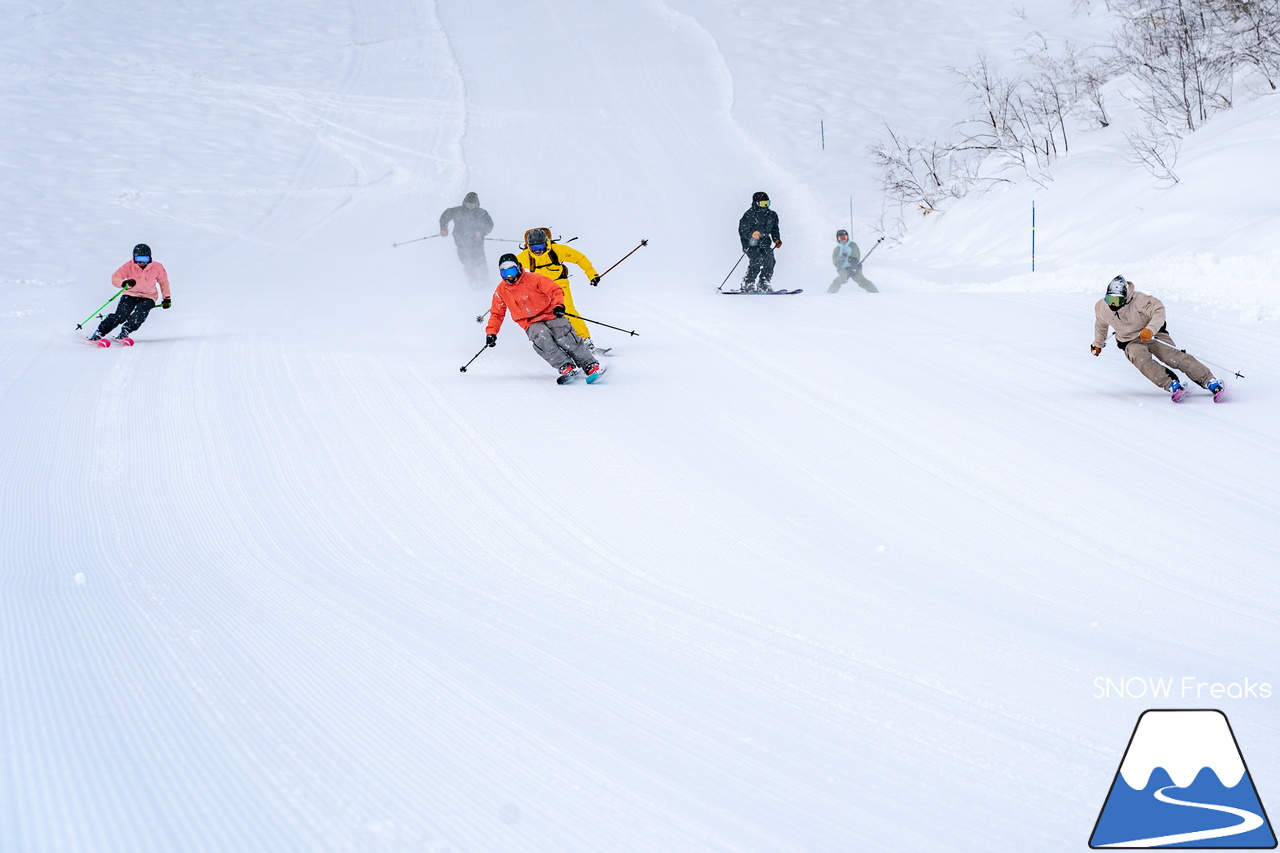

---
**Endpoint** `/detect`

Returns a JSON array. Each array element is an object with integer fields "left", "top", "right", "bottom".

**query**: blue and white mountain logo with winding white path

[{"left": 1089, "top": 711, "right": 1276, "bottom": 850}]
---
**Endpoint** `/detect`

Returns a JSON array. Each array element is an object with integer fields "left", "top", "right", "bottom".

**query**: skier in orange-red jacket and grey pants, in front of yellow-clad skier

[{"left": 484, "top": 252, "right": 605, "bottom": 386}]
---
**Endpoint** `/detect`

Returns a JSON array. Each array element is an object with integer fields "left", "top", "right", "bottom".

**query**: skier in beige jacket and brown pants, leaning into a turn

[{"left": 1089, "top": 275, "right": 1226, "bottom": 402}]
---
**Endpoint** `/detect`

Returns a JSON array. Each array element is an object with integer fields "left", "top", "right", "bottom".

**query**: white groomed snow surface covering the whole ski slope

[{"left": 0, "top": 0, "right": 1280, "bottom": 853}]
